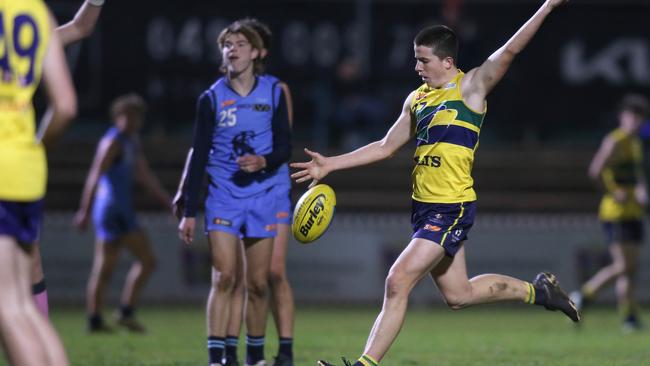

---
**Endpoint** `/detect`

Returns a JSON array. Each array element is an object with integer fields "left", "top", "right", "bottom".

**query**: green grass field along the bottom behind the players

[{"left": 0, "top": 306, "right": 650, "bottom": 366}]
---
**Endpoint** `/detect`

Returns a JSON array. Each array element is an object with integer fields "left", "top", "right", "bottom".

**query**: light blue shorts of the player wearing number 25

[{"left": 205, "top": 188, "right": 277, "bottom": 238}]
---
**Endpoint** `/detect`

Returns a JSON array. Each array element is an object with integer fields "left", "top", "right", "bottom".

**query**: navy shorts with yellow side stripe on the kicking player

[{"left": 411, "top": 200, "right": 476, "bottom": 257}]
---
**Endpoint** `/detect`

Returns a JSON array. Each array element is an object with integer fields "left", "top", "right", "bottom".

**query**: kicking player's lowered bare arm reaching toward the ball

[{"left": 291, "top": 93, "right": 414, "bottom": 187}]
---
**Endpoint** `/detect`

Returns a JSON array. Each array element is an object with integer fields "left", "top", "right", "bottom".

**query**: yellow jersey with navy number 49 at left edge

[{"left": 0, "top": 0, "right": 50, "bottom": 202}]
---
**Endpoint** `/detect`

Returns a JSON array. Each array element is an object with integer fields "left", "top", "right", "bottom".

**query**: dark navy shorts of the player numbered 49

[{"left": 0, "top": 200, "right": 43, "bottom": 244}]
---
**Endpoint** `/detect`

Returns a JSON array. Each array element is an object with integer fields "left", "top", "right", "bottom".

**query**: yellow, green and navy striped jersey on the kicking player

[{"left": 411, "top": 72, "right": 485, "bottom": 203}]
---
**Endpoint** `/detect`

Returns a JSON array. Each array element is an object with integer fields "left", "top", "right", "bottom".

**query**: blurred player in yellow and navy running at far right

[{"left": 571, "top": 94, "right": 650, "bottom": 330}]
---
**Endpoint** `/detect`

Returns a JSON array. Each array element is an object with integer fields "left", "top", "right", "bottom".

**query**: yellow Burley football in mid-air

[{"left": 291, "top": 184, "right": 336, "bottom": 244}]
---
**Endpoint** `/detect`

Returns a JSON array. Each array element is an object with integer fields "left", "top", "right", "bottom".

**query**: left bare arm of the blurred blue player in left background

[{"left": 74, "top": 138, "right": 121, "bottom": 229}]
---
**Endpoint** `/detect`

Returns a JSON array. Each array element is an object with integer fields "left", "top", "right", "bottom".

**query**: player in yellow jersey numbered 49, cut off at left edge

[{"left": 0, "top": 0, "right": 77, "bottom": 365}]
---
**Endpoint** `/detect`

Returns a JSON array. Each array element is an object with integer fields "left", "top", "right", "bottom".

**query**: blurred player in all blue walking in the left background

[{"left": 74, "top": 94, "right": 171, "bottom": 332}]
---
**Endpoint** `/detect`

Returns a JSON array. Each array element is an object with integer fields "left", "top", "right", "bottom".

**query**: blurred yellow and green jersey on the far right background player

[{"left": 598, "top": 129, "right": 644, "bottom": 221}]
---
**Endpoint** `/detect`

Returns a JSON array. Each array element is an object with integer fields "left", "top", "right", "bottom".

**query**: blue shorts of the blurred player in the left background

[{"left": 93, "top": 201, "right": 140, "bottom": 242}]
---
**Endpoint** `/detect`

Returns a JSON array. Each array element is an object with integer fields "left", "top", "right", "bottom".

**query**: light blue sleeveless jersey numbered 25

[{"left": 207, "top": 76, "right": 281, "bottom": 198}]
